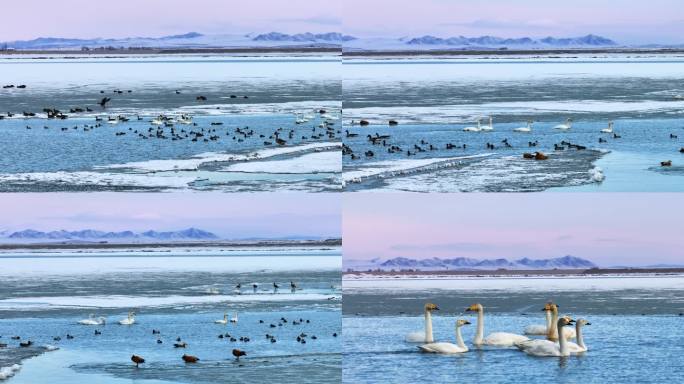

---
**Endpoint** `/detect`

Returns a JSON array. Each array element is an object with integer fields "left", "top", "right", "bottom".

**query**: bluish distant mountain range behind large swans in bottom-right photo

[{"left": 345, "top": 255, "right": 597, "bottom": 271}]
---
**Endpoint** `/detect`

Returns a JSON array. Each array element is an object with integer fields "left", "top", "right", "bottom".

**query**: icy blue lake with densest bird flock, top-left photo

[{"left": 0, "top": 56, "right": 341, "bottom": 192}]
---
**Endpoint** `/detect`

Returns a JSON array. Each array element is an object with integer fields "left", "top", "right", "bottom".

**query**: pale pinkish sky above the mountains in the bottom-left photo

[{"left": 0, "top": 193, "right": 342, "bottom": 238}]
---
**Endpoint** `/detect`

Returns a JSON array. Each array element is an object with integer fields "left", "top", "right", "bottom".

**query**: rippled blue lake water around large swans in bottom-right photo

[{"left": 342, "top": 275, "right": 684, "bottom": 383}]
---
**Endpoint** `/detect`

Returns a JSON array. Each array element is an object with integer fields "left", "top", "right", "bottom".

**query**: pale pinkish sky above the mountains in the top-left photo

[{"left": 0, "top": 0, "right": 341, "bottom": 41}]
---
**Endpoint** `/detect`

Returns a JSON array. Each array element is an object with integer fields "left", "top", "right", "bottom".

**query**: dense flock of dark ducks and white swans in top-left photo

[{"left": 0, "top": 86, "right": 340, "bottom": 150}]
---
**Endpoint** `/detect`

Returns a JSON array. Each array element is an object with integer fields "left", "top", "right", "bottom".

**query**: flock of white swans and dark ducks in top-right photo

[{"left": 342, "top": 116, "right": 684, "bottom": 166}]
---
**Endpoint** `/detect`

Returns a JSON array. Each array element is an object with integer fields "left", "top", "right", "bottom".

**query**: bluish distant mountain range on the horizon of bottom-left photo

[{"left": 2, "top": 228, "right": 219, "bottom": 241}]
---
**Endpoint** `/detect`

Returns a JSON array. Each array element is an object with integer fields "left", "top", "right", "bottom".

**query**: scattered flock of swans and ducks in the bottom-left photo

[{"left": 0, "top": 281, "right": 338, "bottom": 367}]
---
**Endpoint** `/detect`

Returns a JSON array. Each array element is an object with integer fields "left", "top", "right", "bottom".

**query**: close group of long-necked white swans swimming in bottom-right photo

[{"left": 405, "top": 302, "right": 591, "bottom": 356}]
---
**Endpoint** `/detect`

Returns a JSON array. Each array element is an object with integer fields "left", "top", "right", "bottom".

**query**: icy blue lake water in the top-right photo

[{"left": 343, "top": 57, "right": 684, "bottom": 192}]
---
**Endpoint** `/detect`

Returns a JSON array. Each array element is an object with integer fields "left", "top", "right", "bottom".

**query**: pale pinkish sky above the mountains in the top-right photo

[{"left": 342, "top": 0, "right": 684, "bottom": 43}]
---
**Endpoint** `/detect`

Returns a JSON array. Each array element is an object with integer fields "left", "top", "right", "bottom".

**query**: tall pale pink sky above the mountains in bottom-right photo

[{"left": 342, "top": 193, "right": 684, "bottom": 266}]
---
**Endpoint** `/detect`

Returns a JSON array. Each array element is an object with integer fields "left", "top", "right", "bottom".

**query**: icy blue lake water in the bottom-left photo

[{"left": 0, "top": 250, "right": 341, "bottom": 383}]
